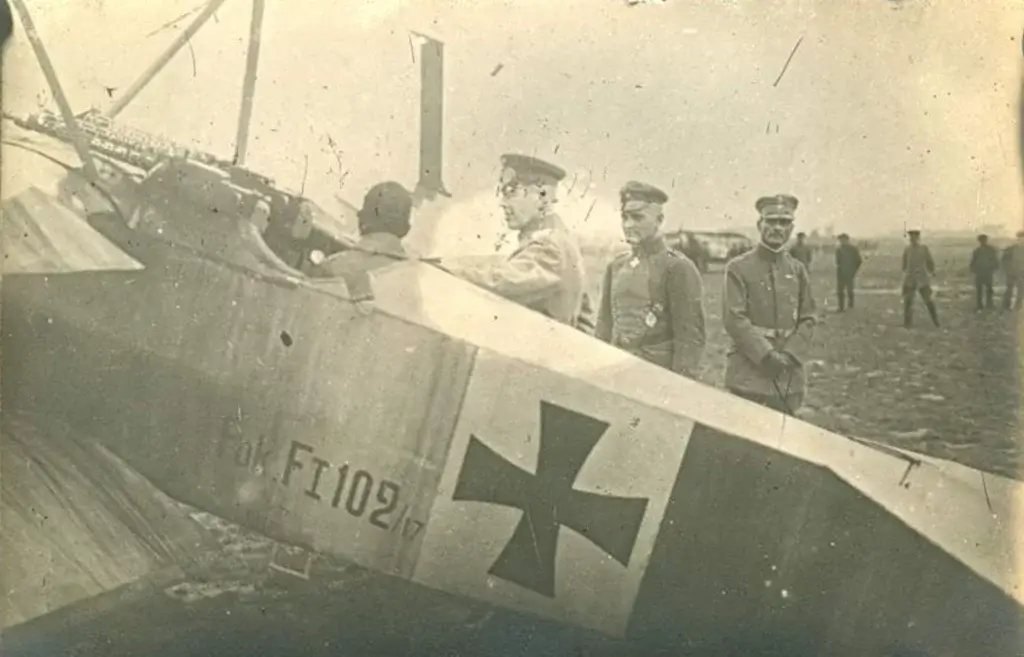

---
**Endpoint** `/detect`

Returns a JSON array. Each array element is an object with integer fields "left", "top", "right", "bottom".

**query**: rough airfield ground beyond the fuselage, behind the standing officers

[{"left": 588, "top": 237, "right": 1024, "bottom": 479}]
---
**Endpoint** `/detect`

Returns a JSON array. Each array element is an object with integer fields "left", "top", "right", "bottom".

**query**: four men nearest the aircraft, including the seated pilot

[{"left": 310, "top": 155, "right": 819, "bottom": 413}]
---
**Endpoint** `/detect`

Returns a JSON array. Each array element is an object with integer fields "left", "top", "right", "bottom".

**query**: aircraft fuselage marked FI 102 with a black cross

[{"left": 2, "top": 185, "right": 1024, "bottom": 655}]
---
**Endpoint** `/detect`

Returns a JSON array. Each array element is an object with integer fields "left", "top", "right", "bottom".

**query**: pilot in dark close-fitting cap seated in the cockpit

[{"left": 309, "top": 181, "right": 413, "bottom": 277}]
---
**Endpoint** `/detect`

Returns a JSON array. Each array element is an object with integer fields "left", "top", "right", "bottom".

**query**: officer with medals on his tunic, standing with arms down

[{"left": 594, "top": 182, "right": 706, "bottom": 379}]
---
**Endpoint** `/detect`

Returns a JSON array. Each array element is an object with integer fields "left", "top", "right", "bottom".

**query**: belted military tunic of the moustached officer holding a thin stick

[{"left": 722, "top": 245, "right": 816, "bottom": 408}]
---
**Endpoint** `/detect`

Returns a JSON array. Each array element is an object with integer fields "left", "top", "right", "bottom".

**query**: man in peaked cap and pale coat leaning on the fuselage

[{"left": 442, "top": 155, "right": 584, "bottom": 326}]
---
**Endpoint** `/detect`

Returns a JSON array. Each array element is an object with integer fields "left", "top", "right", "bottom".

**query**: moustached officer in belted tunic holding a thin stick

[{"left": 722, "top": 194, "right": 816, "bottom": 414}]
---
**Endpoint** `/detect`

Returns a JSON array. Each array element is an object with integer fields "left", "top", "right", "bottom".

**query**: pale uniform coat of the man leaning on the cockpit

[{"left": 452, "top": 214, "right": 584, "bottom": 326}]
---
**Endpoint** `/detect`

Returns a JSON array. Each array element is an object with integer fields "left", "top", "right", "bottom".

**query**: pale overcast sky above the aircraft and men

[{"left": 4, "top": 0, "right": 1024, "bottom": 245}]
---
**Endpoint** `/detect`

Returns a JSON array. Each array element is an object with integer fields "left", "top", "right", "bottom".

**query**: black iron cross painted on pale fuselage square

[{"left": 453, "top": 401, "right": 648, "bottom": 598}]
